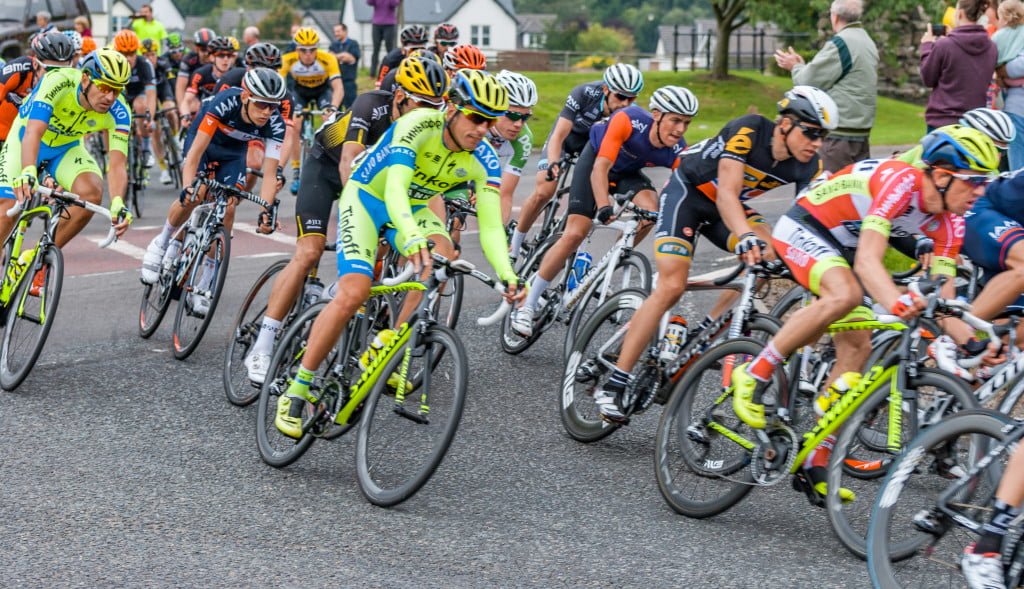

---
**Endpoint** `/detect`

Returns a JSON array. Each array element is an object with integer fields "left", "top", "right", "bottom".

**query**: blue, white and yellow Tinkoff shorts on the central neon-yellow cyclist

[{"left": 337, "top": 182, "right": 447, "bottom": 278}]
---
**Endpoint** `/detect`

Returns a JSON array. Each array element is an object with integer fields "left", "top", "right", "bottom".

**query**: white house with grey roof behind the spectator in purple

[{"left": 341, "top": 0, "right": 518, "bottom": 57}]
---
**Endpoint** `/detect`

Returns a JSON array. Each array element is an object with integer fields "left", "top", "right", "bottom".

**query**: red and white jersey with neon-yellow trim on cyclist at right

[{"left": 790, "top": 160, "right": 965, "bottom": 259}]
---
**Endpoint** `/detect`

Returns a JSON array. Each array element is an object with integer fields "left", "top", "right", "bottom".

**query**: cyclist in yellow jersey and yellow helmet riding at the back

[{"left": 281, "top": 27, "right": 344, "bottom": 195}]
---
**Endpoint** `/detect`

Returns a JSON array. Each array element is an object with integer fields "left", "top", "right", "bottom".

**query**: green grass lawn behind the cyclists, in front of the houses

[{"left": 359, "top": 72, "right": 925, "bottom": 148}]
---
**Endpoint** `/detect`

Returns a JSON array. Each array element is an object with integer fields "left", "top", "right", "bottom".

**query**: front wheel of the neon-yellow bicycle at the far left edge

[{"left": 0, "top": 245, "right": 63, "bottom": 390}]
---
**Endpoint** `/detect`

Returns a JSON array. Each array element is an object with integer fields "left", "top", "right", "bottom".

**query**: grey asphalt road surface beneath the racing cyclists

[{"left": 0, "top": 153, "right": 913, "bottom": 588}]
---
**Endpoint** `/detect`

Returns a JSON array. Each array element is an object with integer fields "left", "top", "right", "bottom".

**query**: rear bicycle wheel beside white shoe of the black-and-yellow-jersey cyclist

[{"left": 223, "top": 259, "right": 291, "bottom": 407}]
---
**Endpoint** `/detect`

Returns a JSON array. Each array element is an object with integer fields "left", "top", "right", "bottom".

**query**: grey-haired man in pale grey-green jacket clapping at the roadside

[{"left": 775, "top": 0, "right": 879, "bottom": 172}]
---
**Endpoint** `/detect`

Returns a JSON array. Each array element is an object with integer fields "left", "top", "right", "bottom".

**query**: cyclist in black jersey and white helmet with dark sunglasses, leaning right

[{"left": 594, "top": 86, "right": 839, "bottom": 421}]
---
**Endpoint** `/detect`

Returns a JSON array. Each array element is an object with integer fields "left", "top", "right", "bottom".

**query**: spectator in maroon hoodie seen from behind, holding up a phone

[{"left": 921, "top": 0, "right": 998, "bottom": 132}]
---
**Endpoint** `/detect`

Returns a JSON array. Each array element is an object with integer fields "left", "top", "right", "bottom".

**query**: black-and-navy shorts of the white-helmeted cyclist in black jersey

[{"left": 654, "top": 172, "right": 767, "bottom": 258}]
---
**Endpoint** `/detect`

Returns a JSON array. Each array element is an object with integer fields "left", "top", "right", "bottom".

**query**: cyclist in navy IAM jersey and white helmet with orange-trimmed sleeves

[{"left": 142, "top": 68, "right": 287, "bottom": 315}]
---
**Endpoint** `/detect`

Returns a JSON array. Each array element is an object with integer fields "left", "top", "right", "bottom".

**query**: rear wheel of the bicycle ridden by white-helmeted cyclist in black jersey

[{"left": 558, "top": 289, "right": 648, "bottom": 444}]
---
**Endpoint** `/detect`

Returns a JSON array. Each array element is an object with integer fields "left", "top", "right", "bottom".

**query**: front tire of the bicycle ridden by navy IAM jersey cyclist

[{"left": 171, "top": 227, "right": 231, "bottom": 360}]
